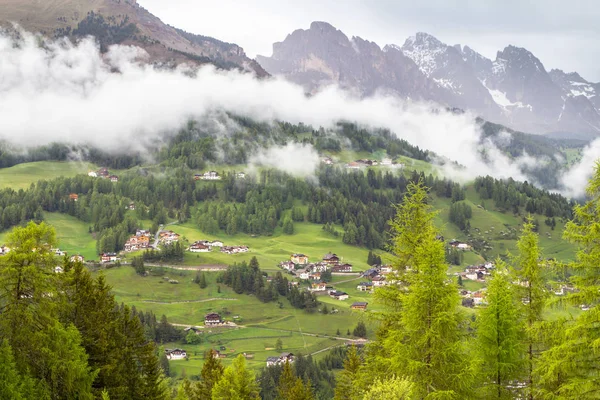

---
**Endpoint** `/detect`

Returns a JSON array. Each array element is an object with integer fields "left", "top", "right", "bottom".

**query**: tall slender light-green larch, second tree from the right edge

[{"left": 515, "top": 217, "right": 548, "bottom": 400}]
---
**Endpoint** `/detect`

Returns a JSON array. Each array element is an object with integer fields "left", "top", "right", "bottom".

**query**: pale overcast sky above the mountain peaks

[{"left": 138, "top": 0, "right": 600, "bottom": 82}]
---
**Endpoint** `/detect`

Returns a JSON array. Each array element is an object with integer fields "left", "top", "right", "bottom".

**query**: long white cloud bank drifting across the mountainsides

[{"left": 0, "top": 34, "right": 600, "bottom": 198}]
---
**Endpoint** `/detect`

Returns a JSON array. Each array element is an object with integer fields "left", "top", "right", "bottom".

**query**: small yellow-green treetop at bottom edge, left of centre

[{"left": 212, "top": 354, "right": 260, "bottom": 400}]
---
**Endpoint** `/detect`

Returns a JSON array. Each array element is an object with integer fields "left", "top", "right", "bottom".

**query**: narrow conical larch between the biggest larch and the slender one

[{"left": 477, "top": 260, "right": 525, "bottom": 399}]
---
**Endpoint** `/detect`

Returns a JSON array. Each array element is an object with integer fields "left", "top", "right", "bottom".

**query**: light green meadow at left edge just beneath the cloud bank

[{"left": 0, "top": 161, "right": 97, "bottom": 190}]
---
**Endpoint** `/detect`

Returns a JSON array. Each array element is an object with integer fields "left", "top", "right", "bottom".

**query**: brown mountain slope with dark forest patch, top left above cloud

[{"left": 0, "top": 0, "right": 267, "bottom": 76}]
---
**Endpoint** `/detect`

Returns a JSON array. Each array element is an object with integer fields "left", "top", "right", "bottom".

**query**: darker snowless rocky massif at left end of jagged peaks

[{"left": 256, "top": 22, "right": 452, "bottom": 100}]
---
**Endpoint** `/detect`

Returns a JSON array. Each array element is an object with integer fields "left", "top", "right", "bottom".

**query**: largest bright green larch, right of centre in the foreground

[{"left": 367, "top": 183, "right": 473, "bottom": 399}]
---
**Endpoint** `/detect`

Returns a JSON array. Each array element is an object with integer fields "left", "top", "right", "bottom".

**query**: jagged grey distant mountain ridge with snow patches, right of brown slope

[{"left": 256, "top": 22, "right": 600, "bottom": 138}]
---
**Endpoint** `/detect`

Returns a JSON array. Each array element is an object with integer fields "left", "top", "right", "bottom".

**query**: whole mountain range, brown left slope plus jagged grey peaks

[{"left": 0, "top": 0, "right": 600, "bottom": 139}]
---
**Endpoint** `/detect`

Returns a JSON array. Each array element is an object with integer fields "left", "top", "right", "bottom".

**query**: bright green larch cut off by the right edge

[{"left": 536, "top": 163, "right": 600, "bottom": 399}]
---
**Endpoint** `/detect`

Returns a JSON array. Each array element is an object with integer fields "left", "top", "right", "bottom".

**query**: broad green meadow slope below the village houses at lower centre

[{"left": 100, "top": 267, "right": 372, "bottom": 374}]
